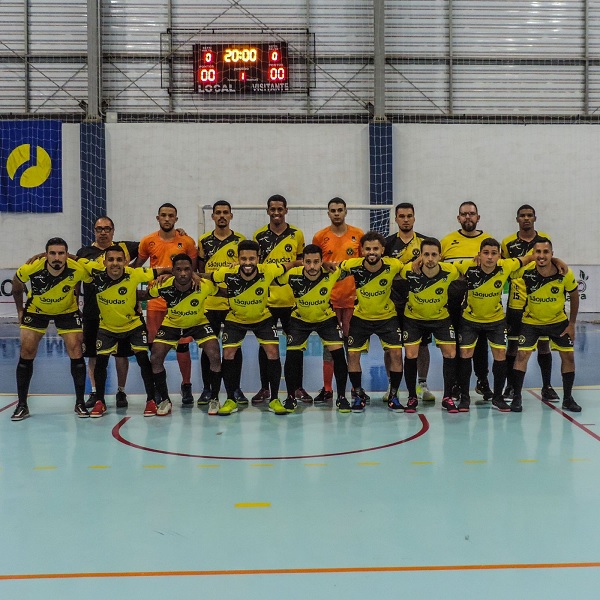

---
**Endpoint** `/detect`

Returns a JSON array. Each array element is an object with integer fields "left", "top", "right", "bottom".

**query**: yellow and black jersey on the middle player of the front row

[{"left": 277, "top": 267, "right": 342, "bottom": 323}]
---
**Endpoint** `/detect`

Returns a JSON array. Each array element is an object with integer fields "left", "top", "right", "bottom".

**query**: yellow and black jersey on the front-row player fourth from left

[{"left": 211, "top": 265, "right": 291, "bottom": 325}]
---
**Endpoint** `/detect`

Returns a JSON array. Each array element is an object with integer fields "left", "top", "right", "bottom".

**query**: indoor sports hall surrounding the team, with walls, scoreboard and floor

[{"left": 0, "top": 0, "right": 600, "bottom": 600}]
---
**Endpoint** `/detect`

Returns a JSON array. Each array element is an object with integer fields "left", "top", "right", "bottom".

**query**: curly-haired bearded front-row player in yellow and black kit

[{"left": 340, "top": 231, "right": 404, "bottom": 412}]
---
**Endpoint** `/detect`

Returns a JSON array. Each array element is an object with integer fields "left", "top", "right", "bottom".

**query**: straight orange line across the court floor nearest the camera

[{"left": 0, "top": 562, "right": 600, "bottom": 581}]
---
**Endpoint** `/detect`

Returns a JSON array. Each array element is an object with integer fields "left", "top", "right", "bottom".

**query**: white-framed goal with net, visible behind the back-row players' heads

[{"left": 198, "top": 204, "right": 394, "bottom": 239}]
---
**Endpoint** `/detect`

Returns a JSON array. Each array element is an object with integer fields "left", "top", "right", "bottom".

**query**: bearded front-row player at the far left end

[{"left": 11, "top": 238, "right": 89, "bottom": 421}]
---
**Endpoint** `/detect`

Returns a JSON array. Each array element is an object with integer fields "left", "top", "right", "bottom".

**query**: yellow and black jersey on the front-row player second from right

[{"left": 455, "top": 258, "right": 522, "bottom": 323}]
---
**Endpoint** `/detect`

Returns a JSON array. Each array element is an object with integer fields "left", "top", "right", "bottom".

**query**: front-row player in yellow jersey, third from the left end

[{"left": 148, "top": 254, "right": 221, "bottom": 417}]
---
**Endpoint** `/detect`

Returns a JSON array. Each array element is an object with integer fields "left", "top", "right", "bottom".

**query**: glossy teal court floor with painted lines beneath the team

[{"left": 0, "top": 323, "right": 600, "bottom": 600}]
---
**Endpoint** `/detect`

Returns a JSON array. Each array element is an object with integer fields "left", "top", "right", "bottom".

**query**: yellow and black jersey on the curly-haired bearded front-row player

[{"left": 340, "top": 256, "right": 404, "bottom": 321}]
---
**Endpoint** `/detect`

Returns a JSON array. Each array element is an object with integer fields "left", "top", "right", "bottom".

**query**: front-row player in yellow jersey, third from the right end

[{"left": 401, "top": 238, "right": 460, "bottom": 413}]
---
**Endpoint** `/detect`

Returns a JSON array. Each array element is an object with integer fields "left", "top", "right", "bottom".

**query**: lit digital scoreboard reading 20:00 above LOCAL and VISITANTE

[{"left": 194, "top": 42, "right": 290, "bottom": 94}]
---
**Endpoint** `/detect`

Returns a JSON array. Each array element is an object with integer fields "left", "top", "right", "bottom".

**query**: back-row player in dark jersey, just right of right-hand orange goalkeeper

[{"left": 383, "top": 202, "right": 435, "bottom": 402}]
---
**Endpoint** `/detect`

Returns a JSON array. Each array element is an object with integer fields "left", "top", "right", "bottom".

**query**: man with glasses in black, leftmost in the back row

[{"left": 77, "top": 217, "right": 138, "bottom": 408}]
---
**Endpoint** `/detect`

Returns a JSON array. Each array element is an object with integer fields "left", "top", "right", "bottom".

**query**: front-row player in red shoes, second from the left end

[{"left": 83, "top": 245, "right": 166, "bottom": 417}]
